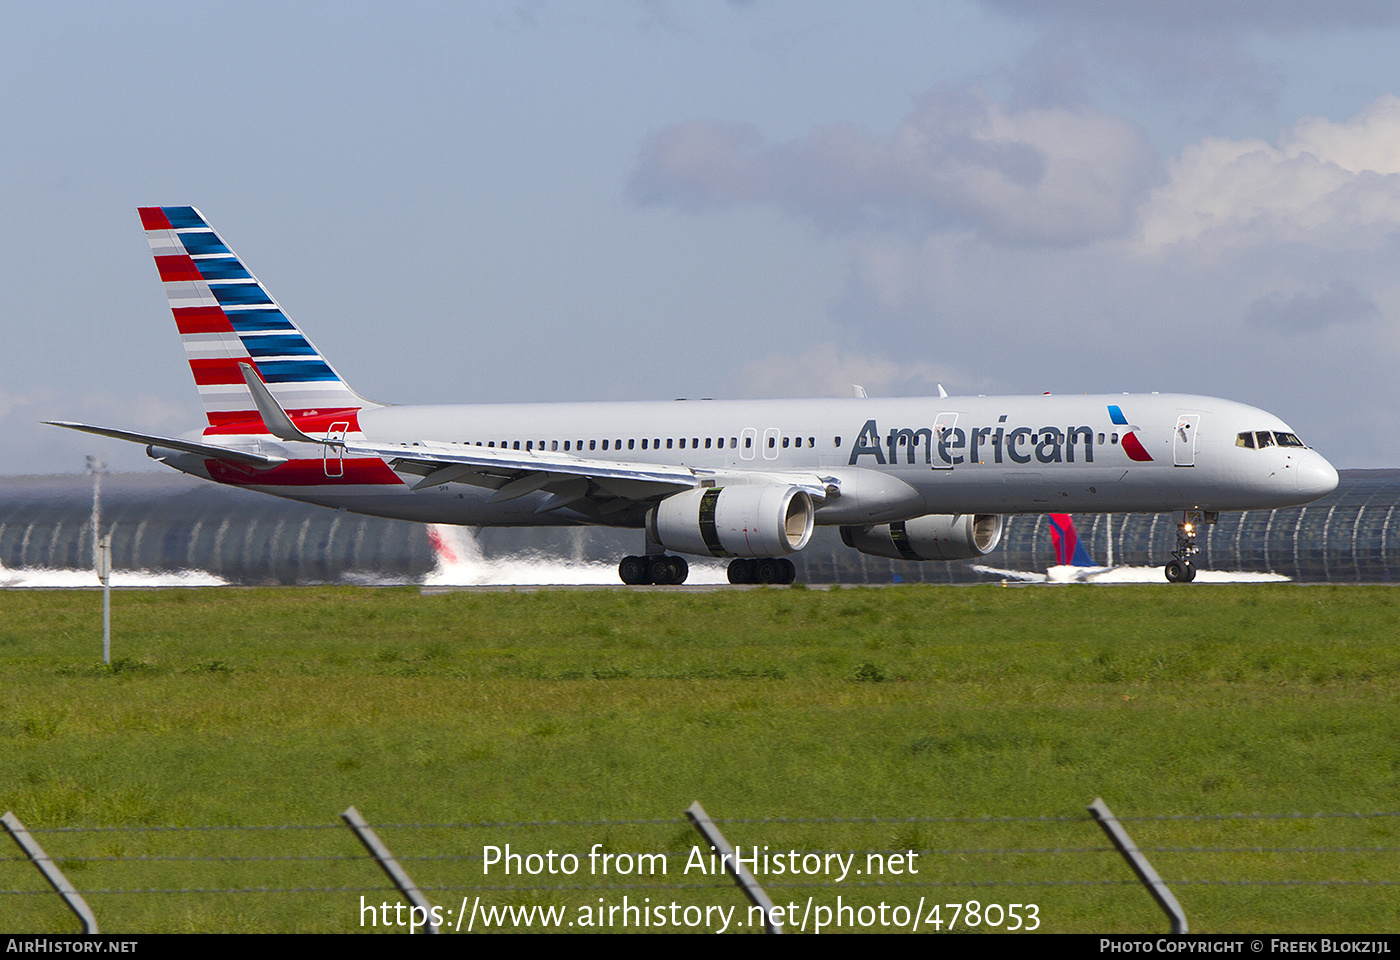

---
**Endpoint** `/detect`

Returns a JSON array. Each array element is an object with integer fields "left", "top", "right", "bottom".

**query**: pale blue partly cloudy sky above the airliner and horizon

[{"left": 0, "top": 0, "right": 1400, "bottom": 474}]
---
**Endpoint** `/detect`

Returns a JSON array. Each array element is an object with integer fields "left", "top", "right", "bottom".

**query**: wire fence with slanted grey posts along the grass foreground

[{"left": 0, "top": 802, "right": 1400, "bottom": 932}]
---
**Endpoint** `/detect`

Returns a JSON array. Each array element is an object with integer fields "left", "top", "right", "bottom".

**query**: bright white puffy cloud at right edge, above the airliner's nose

[{"left": 1141, "top": 94, "right": 1400, "bottom": 250}]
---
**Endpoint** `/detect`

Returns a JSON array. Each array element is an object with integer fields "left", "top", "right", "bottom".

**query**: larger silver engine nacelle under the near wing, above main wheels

[{"left": 647, "top": 483, "right": 816, "bottom": 557}]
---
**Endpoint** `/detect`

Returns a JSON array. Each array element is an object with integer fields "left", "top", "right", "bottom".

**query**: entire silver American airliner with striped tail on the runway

[{"left": 48, "top": 207, "right": 1337, "bottom": 584}]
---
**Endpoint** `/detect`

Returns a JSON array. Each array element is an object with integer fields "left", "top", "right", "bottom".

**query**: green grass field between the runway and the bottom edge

[{"left": 0, "top": 585, "right": 1400, "bottom": 932}]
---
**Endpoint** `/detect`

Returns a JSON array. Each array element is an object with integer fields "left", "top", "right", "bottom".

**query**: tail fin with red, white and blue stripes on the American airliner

[{"left": 140, "top": 207, "right": 379, "bottom": 435}]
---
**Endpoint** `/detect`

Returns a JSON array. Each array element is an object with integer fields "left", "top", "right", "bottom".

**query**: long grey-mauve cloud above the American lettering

[{"left": 629, "top": 91, "right": 1156, "bottom": 245}]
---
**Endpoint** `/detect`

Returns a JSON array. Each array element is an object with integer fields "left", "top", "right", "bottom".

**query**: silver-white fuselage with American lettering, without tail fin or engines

[{"left": 164, "top": 393, "right": 1337, "bottom": 526}]
